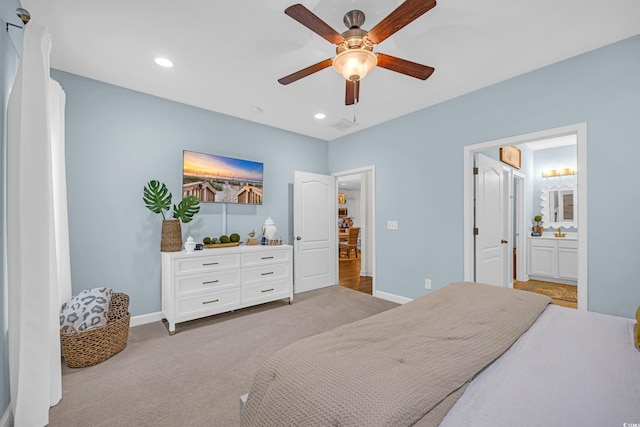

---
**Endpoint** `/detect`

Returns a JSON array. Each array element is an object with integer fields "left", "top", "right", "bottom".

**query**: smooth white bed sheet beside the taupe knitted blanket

[{"left": 441, "top": 305, "right": 640, "bottom": 427}]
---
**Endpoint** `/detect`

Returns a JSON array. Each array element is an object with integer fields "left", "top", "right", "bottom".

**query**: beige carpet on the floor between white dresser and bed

[{"left": 49, "top": 286, "right": 396, "bottom": 427}]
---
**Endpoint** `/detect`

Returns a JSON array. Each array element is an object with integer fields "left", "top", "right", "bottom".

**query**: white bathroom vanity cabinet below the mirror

[{"left": 529, "top": 233, "right": 578, "bottom": 285}]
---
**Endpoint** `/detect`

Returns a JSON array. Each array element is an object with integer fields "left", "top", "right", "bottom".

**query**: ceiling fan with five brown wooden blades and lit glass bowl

[{"left": 278, "top": 0, "right": 436, "bottom": 105}]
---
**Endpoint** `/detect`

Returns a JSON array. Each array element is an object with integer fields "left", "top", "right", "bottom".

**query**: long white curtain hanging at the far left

[{"left": 7, "top": 21, "right": 71, "bottom": 427}]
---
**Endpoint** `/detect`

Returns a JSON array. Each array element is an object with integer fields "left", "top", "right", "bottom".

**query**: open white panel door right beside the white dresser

[{"left": 293, "top": 171, "right": 338, "bottom": 293}]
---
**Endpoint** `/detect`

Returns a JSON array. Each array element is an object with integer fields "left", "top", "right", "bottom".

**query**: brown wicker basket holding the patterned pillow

[{"left": 60, "top": 292, "right": 131, "bottom": 368}]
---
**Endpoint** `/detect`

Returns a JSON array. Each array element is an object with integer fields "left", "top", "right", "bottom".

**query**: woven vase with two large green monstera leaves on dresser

[{"left": 142, "top": 180, "right": 200, "bottom": 252}]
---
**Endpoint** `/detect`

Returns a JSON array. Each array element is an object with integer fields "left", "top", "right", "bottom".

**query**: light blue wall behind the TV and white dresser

[{"left": 52, "top": 70, "right": 328, "bottom": 315}]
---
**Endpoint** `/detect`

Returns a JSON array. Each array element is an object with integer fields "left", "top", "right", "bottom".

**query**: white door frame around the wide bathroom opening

[{"left": 463, "top": 123, "right": 589, "bottom": 311}]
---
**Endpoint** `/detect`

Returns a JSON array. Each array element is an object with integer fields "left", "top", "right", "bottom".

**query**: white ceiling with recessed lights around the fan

[{"left": 16, "top": 0, "right": 640, "bottom": 140}]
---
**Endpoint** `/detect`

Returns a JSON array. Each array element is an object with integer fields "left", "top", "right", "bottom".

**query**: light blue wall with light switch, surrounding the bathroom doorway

[{"left": 329, "top": 36, "right": 640, "bottom": 317}]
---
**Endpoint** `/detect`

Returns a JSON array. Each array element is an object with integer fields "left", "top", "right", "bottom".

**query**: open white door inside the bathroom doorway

[{"left": 474, "top": 154, "right": 508, "bottom": 286}]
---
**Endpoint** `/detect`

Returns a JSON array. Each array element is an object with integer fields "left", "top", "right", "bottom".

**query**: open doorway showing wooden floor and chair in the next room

[{"left": 334, "top": 166, "right": 375, "bottom": 295}]
